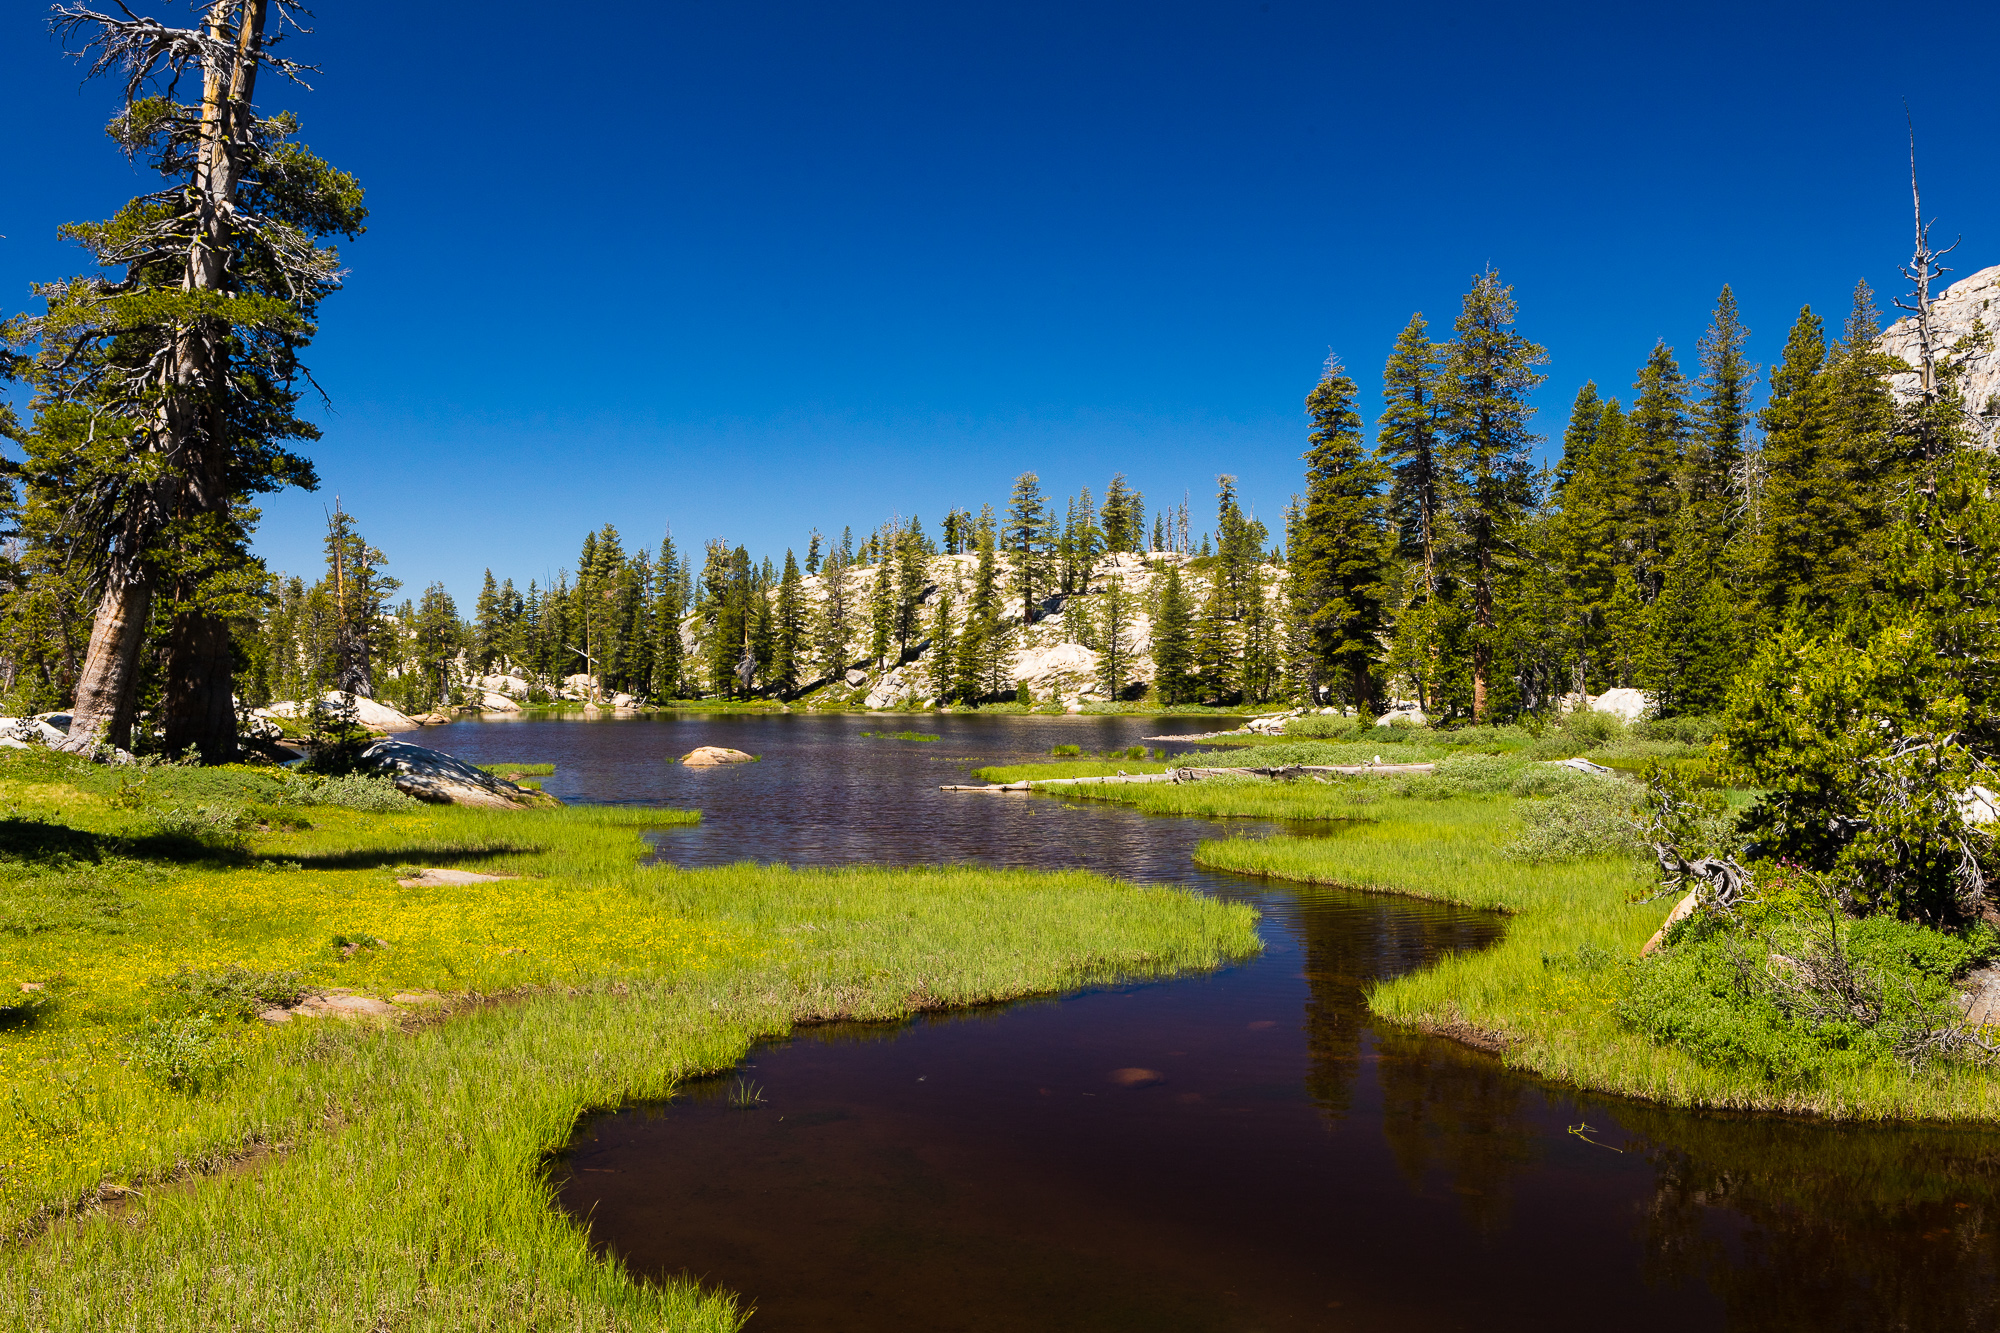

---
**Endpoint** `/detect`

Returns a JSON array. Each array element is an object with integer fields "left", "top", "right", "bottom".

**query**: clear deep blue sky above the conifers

[{"left": 0, "top": 0, "right": 2000, "bottom": 610}]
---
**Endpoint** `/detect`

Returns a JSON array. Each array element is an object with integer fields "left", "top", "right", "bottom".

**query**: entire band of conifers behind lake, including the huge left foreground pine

[{"left": 11, "top": 0, "right": 1986, "bottom": 740}]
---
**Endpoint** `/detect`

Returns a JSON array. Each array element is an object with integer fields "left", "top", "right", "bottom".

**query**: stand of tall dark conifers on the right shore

[{"left": 1290, "top": 272, "right": 1974, "bottom": 719}]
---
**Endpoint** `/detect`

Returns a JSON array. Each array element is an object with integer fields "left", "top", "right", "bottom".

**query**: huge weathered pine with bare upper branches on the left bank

[{"left": 12, "top": 0, "right": 368, "bottom": 763}]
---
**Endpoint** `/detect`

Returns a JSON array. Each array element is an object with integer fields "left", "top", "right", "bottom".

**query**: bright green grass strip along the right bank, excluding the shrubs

[{"left": 1016, "top": 741, "right": 2000, "bottom": 1121}]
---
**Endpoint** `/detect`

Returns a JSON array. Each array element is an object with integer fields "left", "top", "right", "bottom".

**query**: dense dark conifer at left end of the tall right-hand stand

[{"left": 1288, "top": 358, "right": 1388, "bottom": 711}]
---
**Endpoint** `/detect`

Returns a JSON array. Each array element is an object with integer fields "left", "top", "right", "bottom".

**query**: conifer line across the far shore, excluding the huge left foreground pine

[{"left": 6, "top": 253, "right": 1984, "bottom": 721}]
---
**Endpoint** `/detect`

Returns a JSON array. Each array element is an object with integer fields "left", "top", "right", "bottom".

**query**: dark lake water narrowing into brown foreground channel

[{"left": 422, "top": 715, "right": 2000, "bottom": 1333}]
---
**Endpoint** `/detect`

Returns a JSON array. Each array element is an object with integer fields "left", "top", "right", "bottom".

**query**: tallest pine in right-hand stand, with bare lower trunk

[{"left": 1442, "top": 270, "right": 1548, "bottom": 721}]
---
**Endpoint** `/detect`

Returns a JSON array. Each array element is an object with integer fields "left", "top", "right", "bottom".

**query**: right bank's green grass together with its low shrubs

[{"left": 984, "top": 719, "right": 2000, "bottom": 1121}]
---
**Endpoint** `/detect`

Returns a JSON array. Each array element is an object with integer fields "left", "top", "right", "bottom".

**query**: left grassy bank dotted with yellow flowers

[{"left": 0, "top": 753, "right": 1256, "bottom": 1329}]
